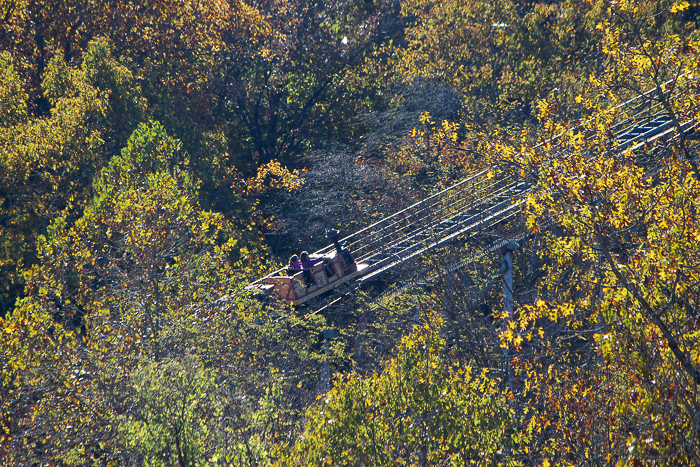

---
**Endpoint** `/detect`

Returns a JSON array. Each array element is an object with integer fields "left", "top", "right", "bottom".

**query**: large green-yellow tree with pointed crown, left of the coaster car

[{"left": 0, "top": 123, "right": 346, "bottom": 465}]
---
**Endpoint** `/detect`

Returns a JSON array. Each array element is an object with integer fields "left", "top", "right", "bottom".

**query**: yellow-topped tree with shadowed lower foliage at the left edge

[{"left": 0, "top": 44, "right": 113, "bottom": 318}]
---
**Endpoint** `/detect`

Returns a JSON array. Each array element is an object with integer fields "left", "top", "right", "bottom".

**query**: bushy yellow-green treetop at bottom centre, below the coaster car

[{"left": 283, "top": 327, "right": 527, "bottom": 465}]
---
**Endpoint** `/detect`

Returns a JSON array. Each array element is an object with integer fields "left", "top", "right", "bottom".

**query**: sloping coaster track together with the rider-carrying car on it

[{"left": 249, "top": 81, "right": 698, "bottom": 305}]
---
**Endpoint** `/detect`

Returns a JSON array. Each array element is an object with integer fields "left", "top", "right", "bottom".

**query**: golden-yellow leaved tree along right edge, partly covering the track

[{"left": 492, "top": 2, "right": 700, "bottom": 465}]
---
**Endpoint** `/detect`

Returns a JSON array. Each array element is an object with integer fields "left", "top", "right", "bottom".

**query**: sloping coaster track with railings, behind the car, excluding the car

[{"left": 308, "top": 78, "right": 698, "bottom": 290}]
